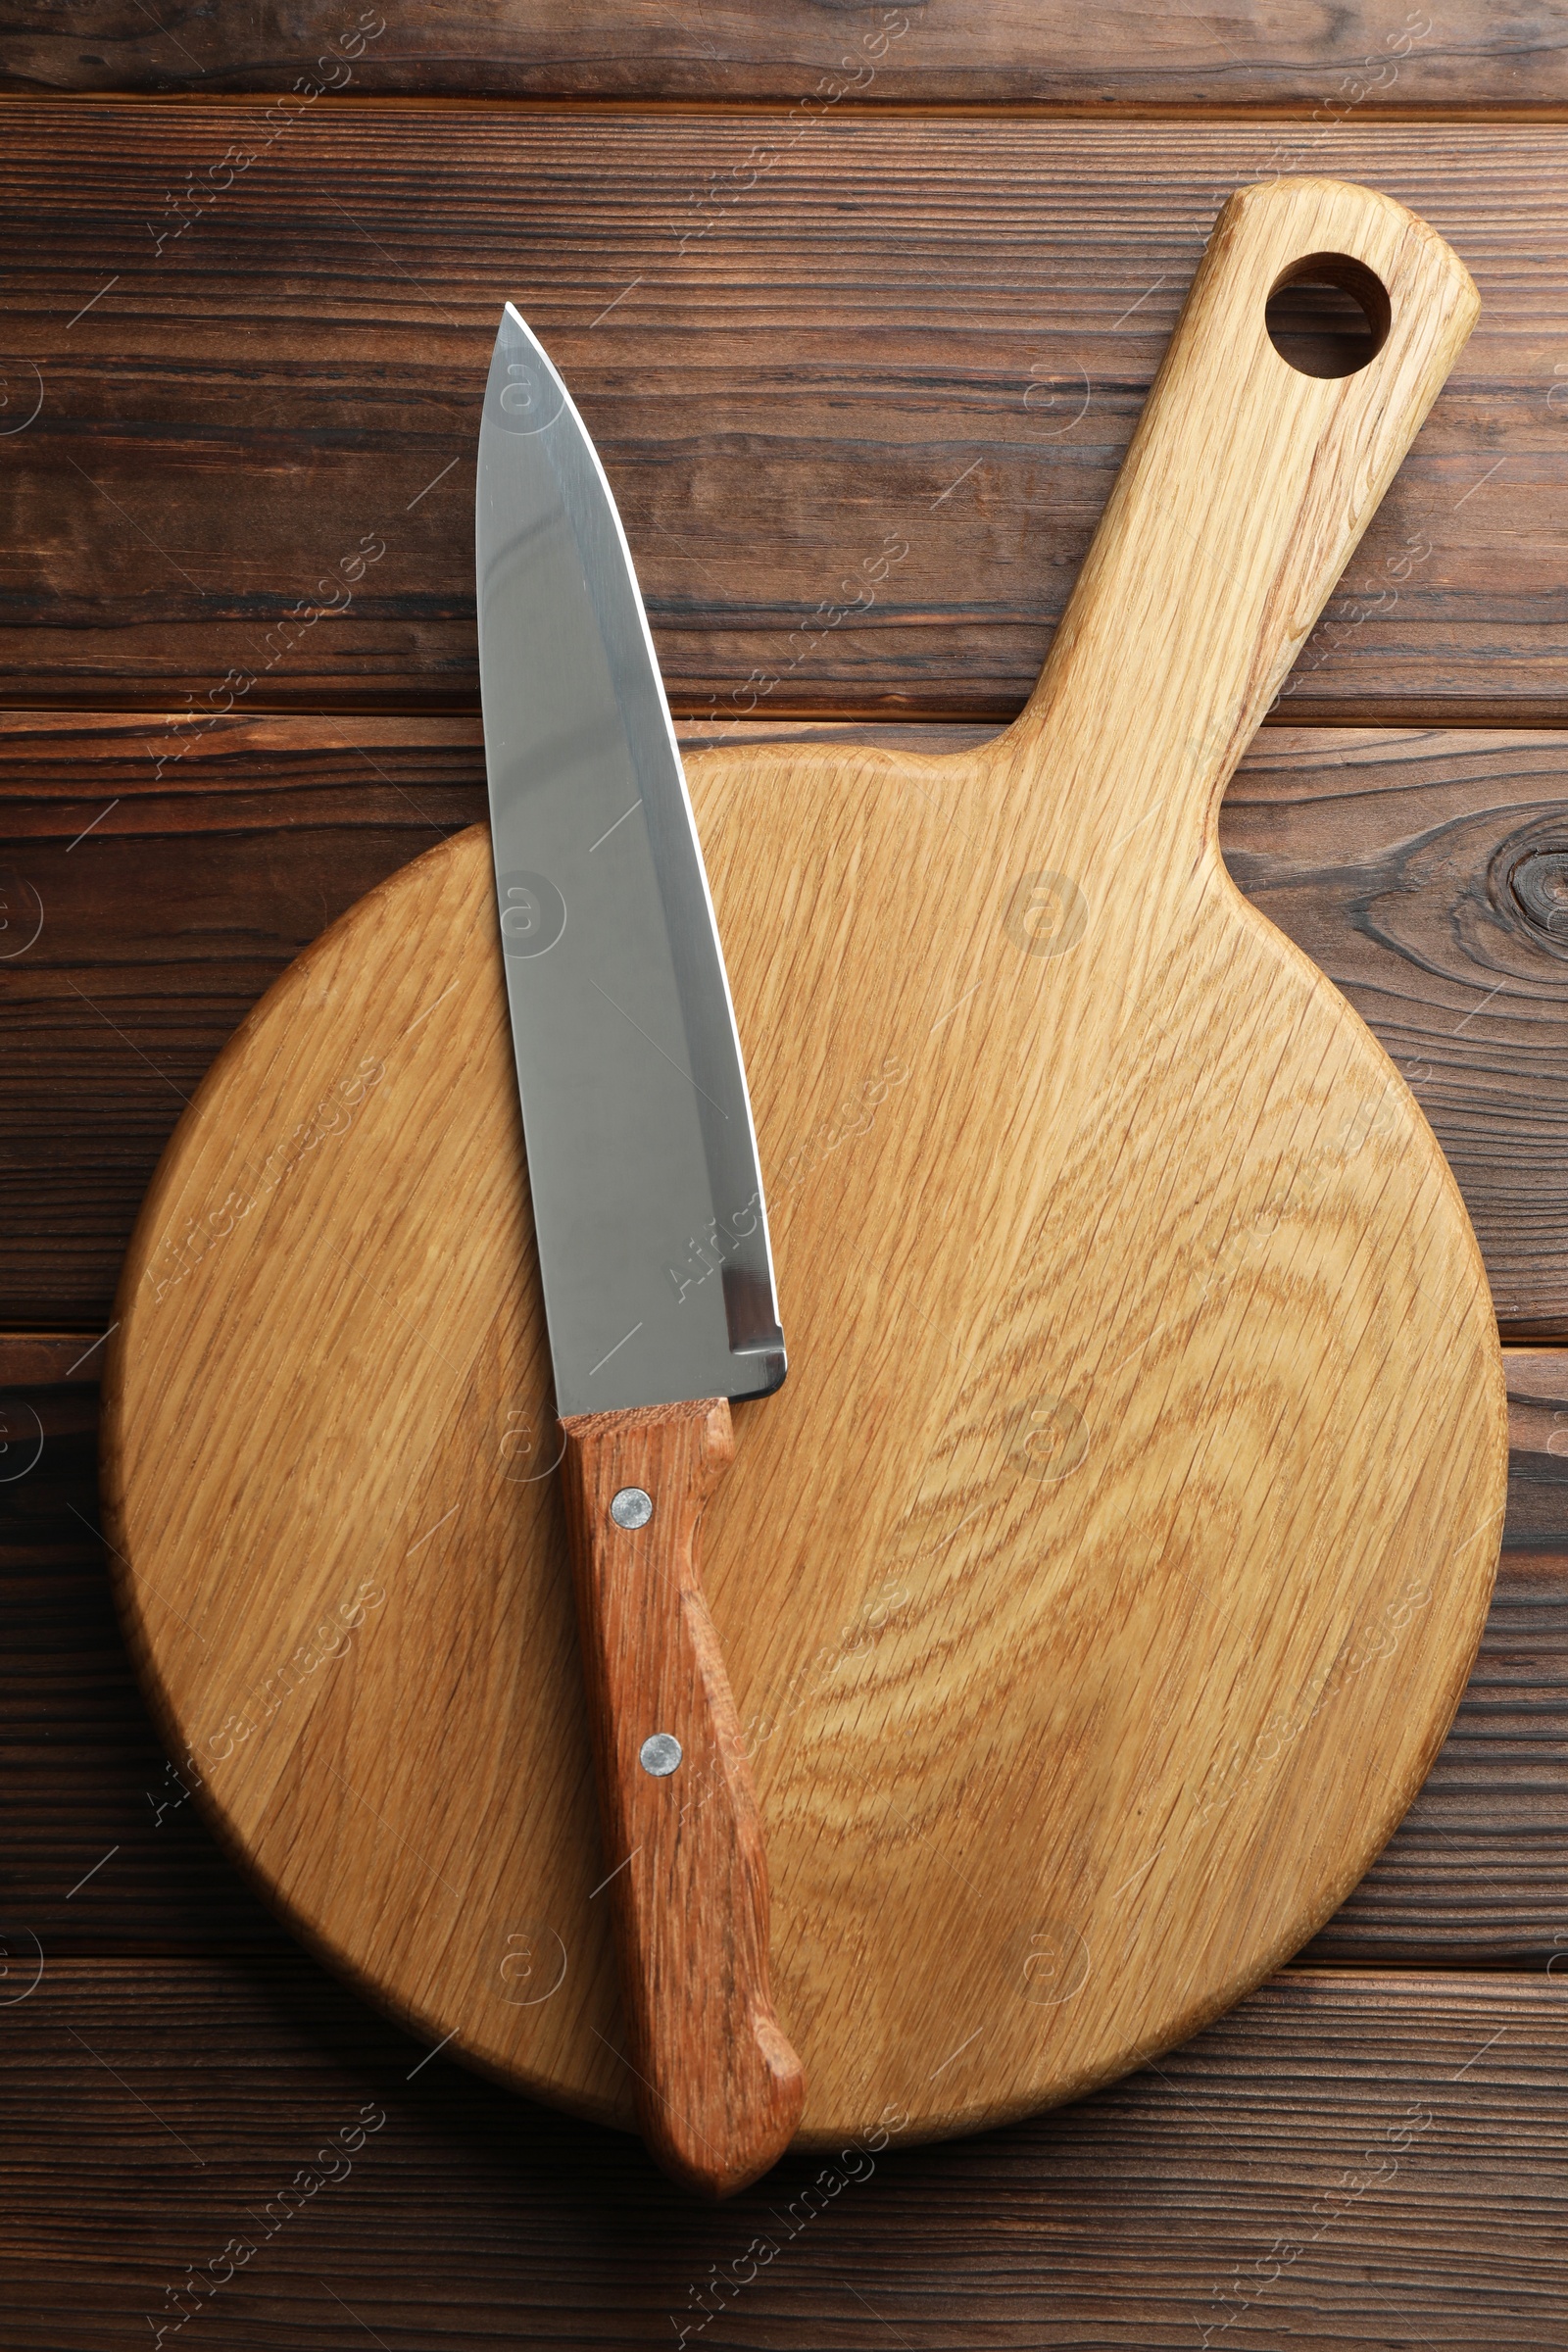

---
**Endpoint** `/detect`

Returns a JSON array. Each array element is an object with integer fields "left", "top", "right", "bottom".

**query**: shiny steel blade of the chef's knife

[{"left": 477, "top": 304, "right": 785, "bottom": 1416}]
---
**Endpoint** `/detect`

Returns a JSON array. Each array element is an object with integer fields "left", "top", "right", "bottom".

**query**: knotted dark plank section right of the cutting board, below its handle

[{"left": 1222, "top": 729, "right": 1568, "bottom": 1339}]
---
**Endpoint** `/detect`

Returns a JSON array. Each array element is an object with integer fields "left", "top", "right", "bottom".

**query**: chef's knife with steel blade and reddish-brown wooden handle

[{"left": 475, "top": 304, "right": 804, "bottom": 2197}]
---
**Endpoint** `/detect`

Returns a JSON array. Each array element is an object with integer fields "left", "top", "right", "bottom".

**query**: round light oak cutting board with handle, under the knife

[{"left": 104, "top": 183, "right": 1507, "bottom": 2145}]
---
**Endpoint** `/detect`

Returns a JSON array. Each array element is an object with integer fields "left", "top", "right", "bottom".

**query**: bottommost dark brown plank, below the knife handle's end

[{"left": 0, "top": 1959, "right": 1568, "bottom": 2352}]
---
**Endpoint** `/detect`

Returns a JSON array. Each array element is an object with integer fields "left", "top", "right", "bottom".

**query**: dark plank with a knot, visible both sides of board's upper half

[{"left": 0, "top": 712, "right": 1568, "bottom": 1346}]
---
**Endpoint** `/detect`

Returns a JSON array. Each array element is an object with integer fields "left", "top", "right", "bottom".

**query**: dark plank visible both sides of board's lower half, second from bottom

[{"left": 0, "top": 1341, "right": 1568, "bottom": 1992}]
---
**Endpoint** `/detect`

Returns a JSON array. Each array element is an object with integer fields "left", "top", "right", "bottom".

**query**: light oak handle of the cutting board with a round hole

[{"left": 995, "top": 178, "right": 1479, "bottom": 872}]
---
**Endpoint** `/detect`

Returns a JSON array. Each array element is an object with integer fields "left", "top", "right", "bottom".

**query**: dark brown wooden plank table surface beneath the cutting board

[{"left": 0, "top": 0, "right": 1568, "bottom": 2352}]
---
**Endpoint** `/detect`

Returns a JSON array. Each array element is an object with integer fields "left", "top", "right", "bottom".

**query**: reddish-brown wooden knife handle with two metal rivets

[{"left": 562, "top": 1397, "right": 807, "bottom": 2197}]
